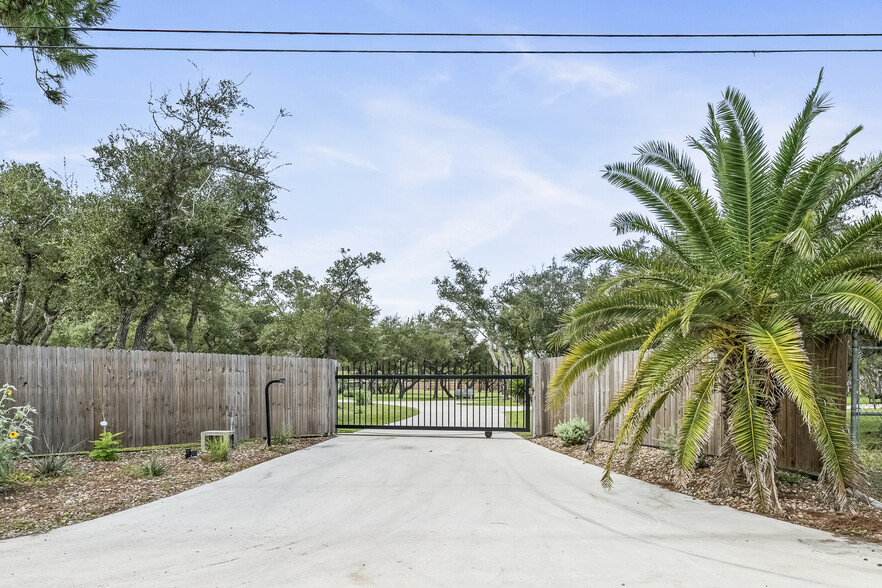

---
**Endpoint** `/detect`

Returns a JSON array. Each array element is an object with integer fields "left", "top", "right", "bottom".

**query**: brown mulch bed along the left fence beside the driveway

[{"left": 0, "top": 437, "right": 327, "bottom": 539}]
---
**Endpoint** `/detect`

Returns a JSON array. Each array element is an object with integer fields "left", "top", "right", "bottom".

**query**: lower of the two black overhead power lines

[{"left": 0, "top": 45, "right": 882, "bottom": 55}]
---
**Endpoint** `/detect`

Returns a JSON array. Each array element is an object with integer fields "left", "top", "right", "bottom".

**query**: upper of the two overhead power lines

[{"left": 4, "top": 25, "right": 882, "bottom": 39}]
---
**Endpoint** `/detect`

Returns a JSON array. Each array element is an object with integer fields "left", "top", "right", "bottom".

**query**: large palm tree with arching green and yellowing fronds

[{"left": 549, "top": 71, "right": 882, "bottom": 510}]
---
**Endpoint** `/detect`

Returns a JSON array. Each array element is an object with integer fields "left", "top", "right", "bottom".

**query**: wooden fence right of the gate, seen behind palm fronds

[{"left": 533, "top": 337, "right": 848, "bottom": 473}]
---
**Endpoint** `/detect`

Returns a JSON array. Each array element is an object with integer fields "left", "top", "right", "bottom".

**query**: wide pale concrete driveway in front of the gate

[{"left": 0, "top": 433, "right": 882, "bottom": 588}]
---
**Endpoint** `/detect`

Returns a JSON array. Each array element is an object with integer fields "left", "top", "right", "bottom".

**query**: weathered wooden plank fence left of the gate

[{"left": 0, "top": 345, "right": 337, "bottom": 452}]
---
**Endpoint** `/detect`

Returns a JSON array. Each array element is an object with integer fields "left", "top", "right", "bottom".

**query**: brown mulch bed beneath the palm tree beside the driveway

[{"left": 532, "top": 437, "right": 882, "bottom": 543}]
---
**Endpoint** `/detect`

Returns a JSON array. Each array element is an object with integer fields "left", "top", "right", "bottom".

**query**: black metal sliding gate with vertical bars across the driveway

[{"left": 337, "top": 365, "right": 531, "bottom": 434}]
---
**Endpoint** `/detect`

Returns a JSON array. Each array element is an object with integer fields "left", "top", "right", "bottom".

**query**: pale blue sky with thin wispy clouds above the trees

[{"left": 0, "top": 0, "right": 882, "bottom": 314}]
